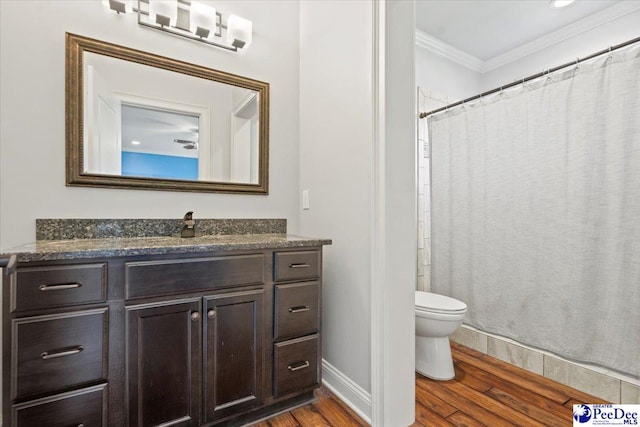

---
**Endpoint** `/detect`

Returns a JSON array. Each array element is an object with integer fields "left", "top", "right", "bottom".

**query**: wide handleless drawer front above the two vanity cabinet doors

[{"left": 125, "top": 254, "right": 264, "bottom": 299}]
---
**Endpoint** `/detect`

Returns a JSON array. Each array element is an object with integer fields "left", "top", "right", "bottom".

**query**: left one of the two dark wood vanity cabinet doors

[{"left": 127, "top": 299, "right": 202, "bottom": 427}]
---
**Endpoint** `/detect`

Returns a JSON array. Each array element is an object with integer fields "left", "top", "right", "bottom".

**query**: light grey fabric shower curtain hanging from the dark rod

[{"left": 429, "top": 43, "right": 640, "bottom": 377}]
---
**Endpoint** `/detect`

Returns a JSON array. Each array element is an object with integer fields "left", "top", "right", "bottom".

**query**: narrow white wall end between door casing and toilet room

[{"left": 373, "top": 1, "right": 418, "bottom": 426}]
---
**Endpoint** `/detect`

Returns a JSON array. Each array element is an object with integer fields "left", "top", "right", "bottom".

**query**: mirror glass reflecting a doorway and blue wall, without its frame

[{"left": 83, "top": 53, "right": 259, "bottom": 184}]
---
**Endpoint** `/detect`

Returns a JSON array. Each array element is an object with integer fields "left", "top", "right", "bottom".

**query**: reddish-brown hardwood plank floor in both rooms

[{"left": 256, "top": 343, "right": 608, "bottom": 427}]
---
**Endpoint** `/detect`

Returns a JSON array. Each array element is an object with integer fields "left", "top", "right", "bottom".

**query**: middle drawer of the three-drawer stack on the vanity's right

[{"left": 274, "top": 282, "right": 319, "bottom": 340}]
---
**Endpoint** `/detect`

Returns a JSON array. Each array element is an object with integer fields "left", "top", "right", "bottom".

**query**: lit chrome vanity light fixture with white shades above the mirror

[{"left": 102, "top": 0, "right": 252, "bottom": 52}]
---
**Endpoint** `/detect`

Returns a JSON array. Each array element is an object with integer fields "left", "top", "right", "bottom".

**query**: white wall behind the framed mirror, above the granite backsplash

[{"left": 0, "top": 0, "right": 302, "bottom": 249}]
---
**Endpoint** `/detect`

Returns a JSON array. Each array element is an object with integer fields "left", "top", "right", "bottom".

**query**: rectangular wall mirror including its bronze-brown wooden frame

[{"left": 66, "top": 33, "right": 269, "bottom": 194}]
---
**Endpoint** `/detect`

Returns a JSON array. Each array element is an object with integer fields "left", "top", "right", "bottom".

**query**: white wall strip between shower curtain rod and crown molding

[{"left": 479, "top": 10, "right": 640, "bottom": 92}]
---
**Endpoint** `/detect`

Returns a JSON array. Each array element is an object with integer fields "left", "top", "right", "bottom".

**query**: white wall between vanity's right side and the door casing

[{"left": 300, "top": 1, "right": 373, "bottom": 415}]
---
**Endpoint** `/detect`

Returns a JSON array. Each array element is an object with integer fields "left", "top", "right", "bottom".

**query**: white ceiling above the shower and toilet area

[{"left": 416, "top": 0, "right": 624, "bottom": 61}]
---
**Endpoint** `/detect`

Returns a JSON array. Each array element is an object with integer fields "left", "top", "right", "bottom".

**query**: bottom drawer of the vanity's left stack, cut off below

[{"left": 11, "top": 384, "right": 107, "bottom": 427}]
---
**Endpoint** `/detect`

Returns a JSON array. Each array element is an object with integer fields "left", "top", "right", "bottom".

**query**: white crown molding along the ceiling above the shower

[{"left": 416, "top": 1, "right": 640, "bottom": 73}]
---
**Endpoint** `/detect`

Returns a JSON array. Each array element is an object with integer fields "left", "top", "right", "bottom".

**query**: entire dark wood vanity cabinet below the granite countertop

[{"left": 3, "top": 247, "right": 321, "bottom": 427}]
